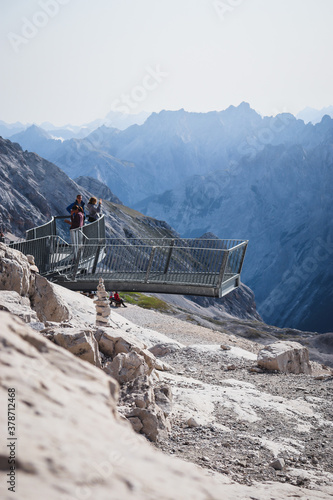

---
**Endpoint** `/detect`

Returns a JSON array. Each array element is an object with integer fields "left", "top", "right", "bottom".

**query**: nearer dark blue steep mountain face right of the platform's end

[{"left": 138, "top": 144, "right": 333, "bottom": 332}]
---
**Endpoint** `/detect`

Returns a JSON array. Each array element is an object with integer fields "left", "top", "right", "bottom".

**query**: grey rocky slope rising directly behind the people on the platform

[{"left": 0, "top": 138, "right": 179, "bottom": 238}]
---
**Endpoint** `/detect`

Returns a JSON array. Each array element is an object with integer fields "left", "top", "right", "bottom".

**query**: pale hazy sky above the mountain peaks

[{"left": 0, "top": 0, "right": 333, "bottom": 125}]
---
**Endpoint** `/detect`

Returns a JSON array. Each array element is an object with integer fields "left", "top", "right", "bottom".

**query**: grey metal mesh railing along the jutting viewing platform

[{"left": 12, "top": 233, "right": 247, "bottom": 287}]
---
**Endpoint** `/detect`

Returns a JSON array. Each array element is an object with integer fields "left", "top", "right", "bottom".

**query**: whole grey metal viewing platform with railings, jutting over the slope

[{"left": 11, "top": 216, "right": 248, "bottom": 297}]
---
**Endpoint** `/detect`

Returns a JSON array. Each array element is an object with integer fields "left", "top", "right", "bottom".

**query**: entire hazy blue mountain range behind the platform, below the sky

[{"left": 3, "top": 103, "right": 333, "bottom": 331}]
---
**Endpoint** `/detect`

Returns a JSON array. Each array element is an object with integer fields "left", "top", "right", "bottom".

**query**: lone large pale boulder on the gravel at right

[{"left": 257, "top": 340, "right": 311, "bottom": 375}]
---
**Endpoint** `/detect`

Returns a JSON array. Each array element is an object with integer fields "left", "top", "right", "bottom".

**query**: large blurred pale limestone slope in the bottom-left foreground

[{"left": 0, "top": 311, "right": 329, "bottom": 500}]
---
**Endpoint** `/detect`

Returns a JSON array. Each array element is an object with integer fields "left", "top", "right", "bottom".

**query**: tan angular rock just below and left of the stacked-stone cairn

[{"left": 53, "top": 328, "right": 101, "bottom": 367}]
